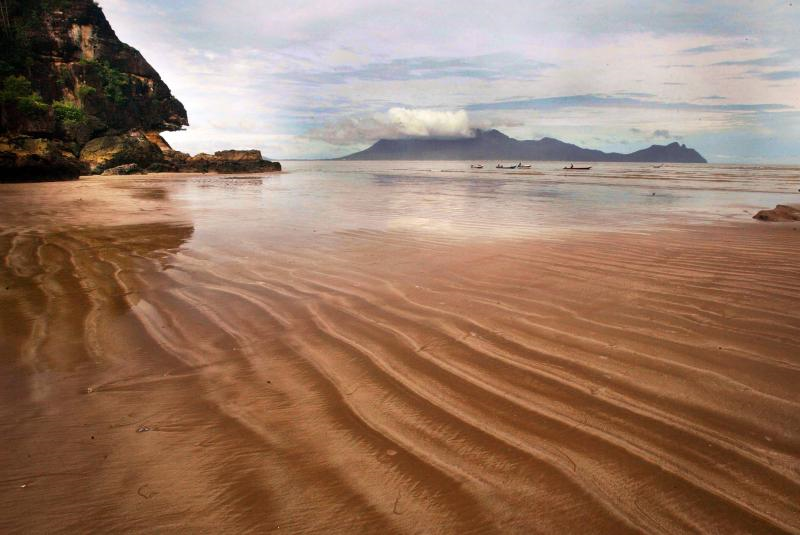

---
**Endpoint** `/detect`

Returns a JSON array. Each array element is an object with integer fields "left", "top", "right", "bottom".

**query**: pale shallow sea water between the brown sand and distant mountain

[{"left": 186, "top": 161, "right": 800, "bottom": 238}]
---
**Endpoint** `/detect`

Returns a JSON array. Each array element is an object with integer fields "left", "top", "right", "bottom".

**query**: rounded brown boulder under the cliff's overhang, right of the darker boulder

[{"left": 80, "top": 132, "right": 164, "bottom": 174}]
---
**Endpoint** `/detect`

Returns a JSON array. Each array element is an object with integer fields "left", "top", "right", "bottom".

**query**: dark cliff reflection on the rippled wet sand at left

[{"left": 0, "top": 223, "right": 193, "bottom": 371}]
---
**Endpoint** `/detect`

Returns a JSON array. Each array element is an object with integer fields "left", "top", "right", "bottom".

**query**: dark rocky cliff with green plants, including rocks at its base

[{"left": 0, "top": 0, "right": 280, "bottom": 180}]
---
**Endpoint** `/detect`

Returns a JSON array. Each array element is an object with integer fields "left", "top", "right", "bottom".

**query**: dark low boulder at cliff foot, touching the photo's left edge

[{"left": 0, "top": 136, "right": 87, "bottom": 182}]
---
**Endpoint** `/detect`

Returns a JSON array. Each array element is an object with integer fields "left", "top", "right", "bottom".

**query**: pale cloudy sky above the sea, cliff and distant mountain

[{"left": 99, "top": 0, "right": 800, "bottom": 163}]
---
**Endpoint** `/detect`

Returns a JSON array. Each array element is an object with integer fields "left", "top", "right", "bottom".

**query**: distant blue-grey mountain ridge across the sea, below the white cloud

[{"left": 338, "top": 130, "right": 707, "bottom": 163}]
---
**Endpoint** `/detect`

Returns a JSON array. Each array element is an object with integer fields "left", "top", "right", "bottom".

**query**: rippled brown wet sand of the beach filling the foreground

[{"left": 0, "top": 171, "right": 800, "bottom": 534}]
